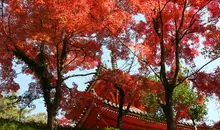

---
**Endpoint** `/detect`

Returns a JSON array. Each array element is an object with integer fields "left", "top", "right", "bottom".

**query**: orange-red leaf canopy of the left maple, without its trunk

[{"left": 1, "top": 0, "right": 130, "bottom": 93}]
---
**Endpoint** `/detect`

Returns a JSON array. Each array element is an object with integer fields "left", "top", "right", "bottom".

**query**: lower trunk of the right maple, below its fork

[{"left": 164, "top": 90, "right": 176, "bottom": 130}]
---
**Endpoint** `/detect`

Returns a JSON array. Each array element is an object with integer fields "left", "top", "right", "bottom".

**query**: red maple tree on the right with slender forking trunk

[{"left": 126, "top": 0, "right": 220, "bottom": 130}]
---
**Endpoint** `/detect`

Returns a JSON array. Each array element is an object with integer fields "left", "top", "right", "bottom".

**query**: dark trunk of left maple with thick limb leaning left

[{"left": 13, "top": 46, "right": 61, "bottom": 130}]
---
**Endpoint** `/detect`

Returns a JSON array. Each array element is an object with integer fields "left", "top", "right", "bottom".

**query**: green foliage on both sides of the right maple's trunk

[{"left": 142, "top": 84, "right": 207, "bottom": 121}]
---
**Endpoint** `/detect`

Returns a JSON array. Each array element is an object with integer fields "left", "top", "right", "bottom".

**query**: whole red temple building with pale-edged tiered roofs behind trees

[{"left": 70, "top": 66, "right": 210, "bottom": 130}]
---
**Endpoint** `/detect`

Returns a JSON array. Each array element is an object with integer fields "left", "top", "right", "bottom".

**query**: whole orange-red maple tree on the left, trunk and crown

[{"left": 0, "top": 0, "right": 130, "bottom": 130}]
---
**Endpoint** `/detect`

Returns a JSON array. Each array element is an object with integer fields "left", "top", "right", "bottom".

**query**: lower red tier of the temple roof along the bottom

[{"left": 75, "top": 102, "right": 210, "bottom": 130}]
